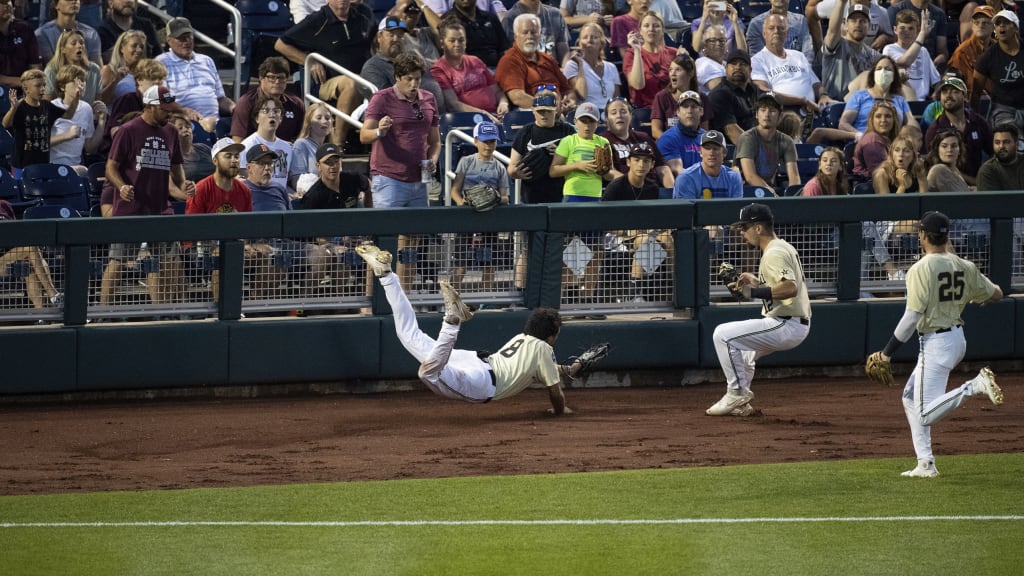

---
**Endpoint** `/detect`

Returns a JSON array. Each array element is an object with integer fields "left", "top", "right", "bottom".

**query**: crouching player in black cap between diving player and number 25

[{"left": 706, "top": 204, "right": 811, "bottom": 416}]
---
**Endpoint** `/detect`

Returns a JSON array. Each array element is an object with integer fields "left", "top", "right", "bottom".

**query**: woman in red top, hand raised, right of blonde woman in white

[{"left": 623, "top": 12, "right": 676, "bottom": 108}]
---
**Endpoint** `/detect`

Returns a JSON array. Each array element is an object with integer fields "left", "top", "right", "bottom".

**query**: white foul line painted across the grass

[{"left": 0, "top": 516, "right": 1024, "bottom": 528}]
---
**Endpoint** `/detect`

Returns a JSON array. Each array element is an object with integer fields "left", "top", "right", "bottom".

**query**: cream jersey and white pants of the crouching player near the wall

[{"left": 712, "top": 238, "right": 811, "bottom": 394}]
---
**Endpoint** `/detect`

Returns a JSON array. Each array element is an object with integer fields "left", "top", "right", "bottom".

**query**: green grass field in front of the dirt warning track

[{"left": 0, "top": 454, "right": 1024, "bottom": 576}]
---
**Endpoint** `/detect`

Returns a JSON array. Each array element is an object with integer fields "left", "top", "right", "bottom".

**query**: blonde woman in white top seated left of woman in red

[{"left": 562, "top": 23, "right": 621, "bottom": 109}]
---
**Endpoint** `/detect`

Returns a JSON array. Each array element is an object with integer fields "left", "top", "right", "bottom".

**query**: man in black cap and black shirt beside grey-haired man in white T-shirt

[{"left": 708, "top": 50, "right": 761, "bottom": 145}]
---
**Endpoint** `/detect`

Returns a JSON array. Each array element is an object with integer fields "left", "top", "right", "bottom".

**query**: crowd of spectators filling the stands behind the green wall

[{"left": 0, "top": 0, "right": 1024, "bottom": 313}]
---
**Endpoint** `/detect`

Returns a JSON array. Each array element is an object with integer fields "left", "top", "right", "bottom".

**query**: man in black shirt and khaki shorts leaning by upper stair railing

[{"left": 273, "top": 0, "right": 377, "bottom": 145}]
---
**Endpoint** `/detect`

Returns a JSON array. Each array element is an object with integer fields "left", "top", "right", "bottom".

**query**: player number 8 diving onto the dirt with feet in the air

[{"left": 355, "top": 244, "right": 581, "bottom": 415}]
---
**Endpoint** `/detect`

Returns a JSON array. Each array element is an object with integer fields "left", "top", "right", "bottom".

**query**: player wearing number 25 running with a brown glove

[{"left": 864, "top": 212, "right": 1002, "bottom": 478}]
